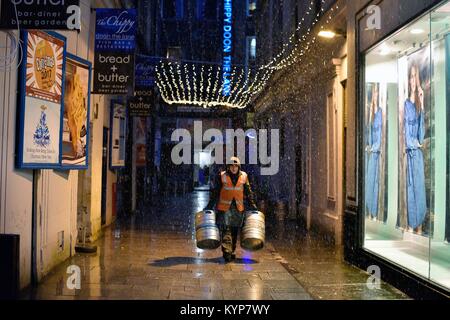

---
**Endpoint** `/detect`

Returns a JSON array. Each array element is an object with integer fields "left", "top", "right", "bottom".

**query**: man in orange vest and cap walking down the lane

[{"left": 205, "top": 157, "right": 257, "bottom": 262}]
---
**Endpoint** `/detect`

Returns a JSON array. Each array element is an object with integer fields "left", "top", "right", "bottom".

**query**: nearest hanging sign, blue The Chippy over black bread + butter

[{"left": 93, "top": 9, "right": 137, "bottom": 95}]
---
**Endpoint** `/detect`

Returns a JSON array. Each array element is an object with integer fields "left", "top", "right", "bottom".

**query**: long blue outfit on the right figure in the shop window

[{"left": 403, "top": 99, "right": 427, "bottom": 229}]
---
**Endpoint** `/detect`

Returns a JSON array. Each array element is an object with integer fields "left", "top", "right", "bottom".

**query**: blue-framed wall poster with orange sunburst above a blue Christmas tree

[{"left": 18, "top": 30, "right": 66, "bottom": 169}]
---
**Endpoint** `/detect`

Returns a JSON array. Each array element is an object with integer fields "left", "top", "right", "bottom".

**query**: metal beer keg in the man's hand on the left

[{"left": 195, "top": 210, "right": 220, "bottom": 250}]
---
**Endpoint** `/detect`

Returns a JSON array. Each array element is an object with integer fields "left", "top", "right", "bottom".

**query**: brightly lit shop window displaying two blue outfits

[{"left": 361, "top": 3, "right": 450, "bottom": 289}]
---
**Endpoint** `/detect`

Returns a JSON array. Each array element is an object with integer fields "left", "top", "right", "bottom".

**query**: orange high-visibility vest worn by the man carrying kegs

[{"left": 217, "top": 171, "right": 247, "bottom": 212}]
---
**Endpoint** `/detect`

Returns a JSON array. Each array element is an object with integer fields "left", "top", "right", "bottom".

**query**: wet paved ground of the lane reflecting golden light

[{"left": 23, "top": 192, "right": 407, "bottom": 300}]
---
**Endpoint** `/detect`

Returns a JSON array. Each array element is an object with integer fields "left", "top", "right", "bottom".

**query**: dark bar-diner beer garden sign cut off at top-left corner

[{"left": 0, "top": 0, "right": 81, "bottom": 30}]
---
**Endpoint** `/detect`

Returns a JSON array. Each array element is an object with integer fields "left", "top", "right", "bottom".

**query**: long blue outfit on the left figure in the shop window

[{"left": 365, "top": 108, "right": 383, "bottom": 218}]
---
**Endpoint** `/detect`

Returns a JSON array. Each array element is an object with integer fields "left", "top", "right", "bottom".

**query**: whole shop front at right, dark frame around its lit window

[{"left": 346, "top": 0, "right": 450, "bottom": 298}]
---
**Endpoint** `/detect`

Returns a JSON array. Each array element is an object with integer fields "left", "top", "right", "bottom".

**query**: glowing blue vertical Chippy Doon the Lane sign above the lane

[{"left": 222, "top": 0, "right": 233, "bottom": 97}]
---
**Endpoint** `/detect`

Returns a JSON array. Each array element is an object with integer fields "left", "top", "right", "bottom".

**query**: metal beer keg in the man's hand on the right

[{"left": 241, "top": 211, "right": 266, "bottom": 251}]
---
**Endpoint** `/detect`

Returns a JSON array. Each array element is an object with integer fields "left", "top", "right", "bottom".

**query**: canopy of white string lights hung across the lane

[{"left": 156, "top": 0, "right": 339, "bottom": 109}]
